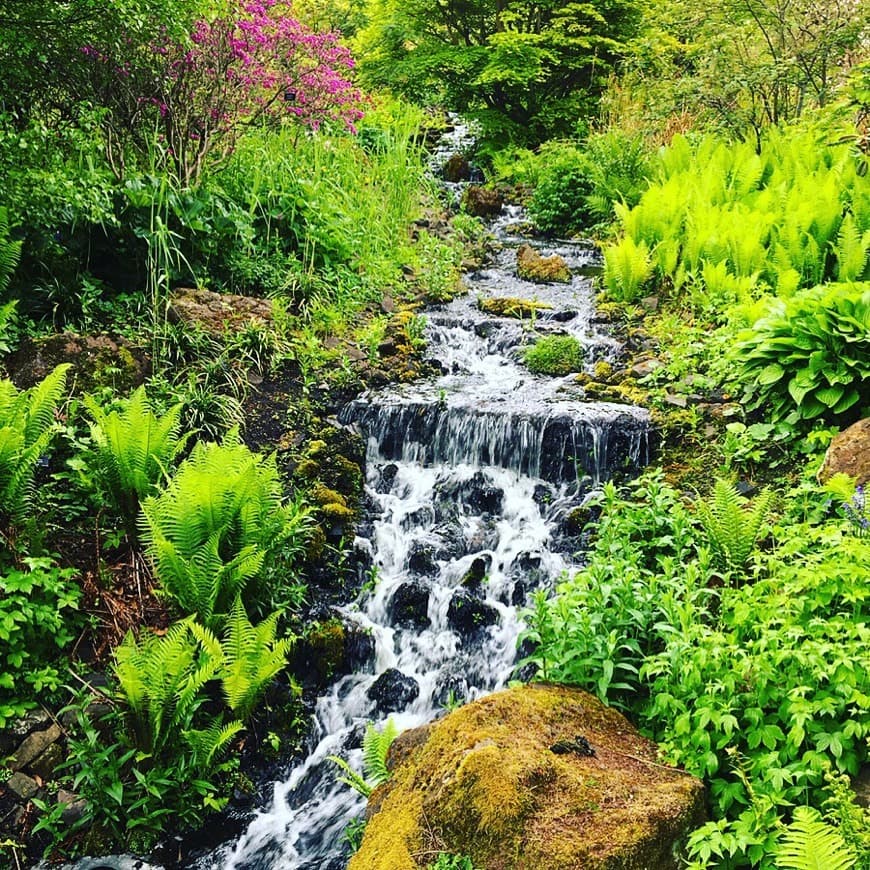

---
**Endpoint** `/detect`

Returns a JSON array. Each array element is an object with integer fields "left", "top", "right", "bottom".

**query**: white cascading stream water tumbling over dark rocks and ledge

[{"left": 204, "top": 199, "right": 648, "bottom": 870}]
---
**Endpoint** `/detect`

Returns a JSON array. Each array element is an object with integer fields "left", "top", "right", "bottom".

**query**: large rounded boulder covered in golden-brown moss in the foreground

[{"left": 348, "top": 685, "right": 704, "bottom": 870}]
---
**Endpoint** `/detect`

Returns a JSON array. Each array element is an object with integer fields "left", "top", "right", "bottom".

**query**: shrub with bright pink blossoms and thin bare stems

[{"left": 82, "top": 0, "right": 363, "bottom": 185}]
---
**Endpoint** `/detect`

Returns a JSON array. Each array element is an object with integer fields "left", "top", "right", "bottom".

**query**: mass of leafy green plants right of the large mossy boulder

[{"left": 526, "top": 474, "right": 870, "bottom": 870}]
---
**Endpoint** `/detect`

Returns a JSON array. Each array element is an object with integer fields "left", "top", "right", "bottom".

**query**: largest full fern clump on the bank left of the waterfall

[{"left": 142, "top": 433, "right": 310, "bottom": 626}]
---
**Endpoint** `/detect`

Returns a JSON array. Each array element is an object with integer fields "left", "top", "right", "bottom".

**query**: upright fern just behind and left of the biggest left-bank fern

[{"left": 84, "top": 387, "right": 190, "bottom": 539}]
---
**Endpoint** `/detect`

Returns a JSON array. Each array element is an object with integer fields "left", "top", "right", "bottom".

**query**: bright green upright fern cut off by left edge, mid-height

[{"left": 0, "top": 365, "right": 69, "bottom": 525}]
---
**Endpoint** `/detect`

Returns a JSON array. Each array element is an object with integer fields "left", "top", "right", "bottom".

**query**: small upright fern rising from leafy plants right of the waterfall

[{"left": 697, "top": 478, "right": 773, "bottom": 575}]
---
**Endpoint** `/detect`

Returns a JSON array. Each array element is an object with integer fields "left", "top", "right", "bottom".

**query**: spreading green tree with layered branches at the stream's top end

[{"left": 357, "top": 0, "right": 638, "bottom": 142}]
